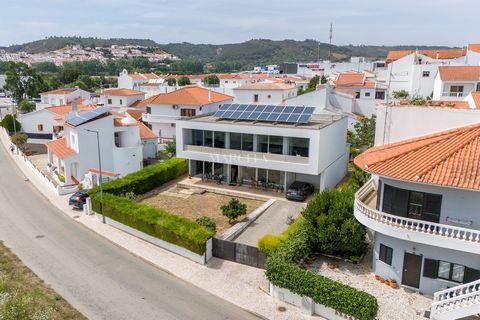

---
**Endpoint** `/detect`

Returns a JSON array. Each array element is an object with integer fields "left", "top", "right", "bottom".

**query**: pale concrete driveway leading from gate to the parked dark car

[{"left": 234, "top": 200, "right": 307, "bottom": 247}]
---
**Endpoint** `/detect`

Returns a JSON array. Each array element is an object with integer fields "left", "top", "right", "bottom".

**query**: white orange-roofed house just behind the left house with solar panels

[{"left": 20, "top": 99, "right": 96, "bottom": 140}]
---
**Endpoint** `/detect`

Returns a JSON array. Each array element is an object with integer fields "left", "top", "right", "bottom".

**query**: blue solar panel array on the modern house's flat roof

[{"left": 214, "top": 103, "right": 315, "bottom": 123}]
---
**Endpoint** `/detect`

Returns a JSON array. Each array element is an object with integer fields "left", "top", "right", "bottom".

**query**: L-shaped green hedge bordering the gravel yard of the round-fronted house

[{"left": 266, "top": 223, "right": 378, "bottom": 320}]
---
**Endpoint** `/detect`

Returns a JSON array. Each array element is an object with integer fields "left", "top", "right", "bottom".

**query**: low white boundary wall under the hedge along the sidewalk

[{"left": 95, "top": 212, "right": 212, "bottom": 264}]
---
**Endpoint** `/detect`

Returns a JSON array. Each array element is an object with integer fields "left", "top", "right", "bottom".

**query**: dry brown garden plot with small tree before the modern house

[{"left": 140, "top": 186, "right": 264, "bottom": 235}]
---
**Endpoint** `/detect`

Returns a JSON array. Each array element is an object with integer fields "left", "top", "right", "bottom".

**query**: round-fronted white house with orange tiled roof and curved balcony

[{"left": 354, "top": 121, "right": 480, "bottom": 319}]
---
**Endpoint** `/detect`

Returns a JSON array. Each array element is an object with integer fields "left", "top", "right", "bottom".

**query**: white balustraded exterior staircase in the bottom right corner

[{"left": 430, "top": 280, "right": 480, "bottom": 320}]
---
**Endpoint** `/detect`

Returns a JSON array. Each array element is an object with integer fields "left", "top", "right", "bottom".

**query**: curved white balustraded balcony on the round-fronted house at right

[{"left": 354, "top": 180, "right": 480, "bottom": 254}]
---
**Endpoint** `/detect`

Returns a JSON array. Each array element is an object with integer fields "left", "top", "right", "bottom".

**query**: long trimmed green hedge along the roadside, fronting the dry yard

[{"left": 91, "top": 193, "right": 215, "bottom": 255}]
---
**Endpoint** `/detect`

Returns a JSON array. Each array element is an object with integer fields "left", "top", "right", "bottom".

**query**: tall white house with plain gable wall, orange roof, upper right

[{"left": 385, "top": 49, "right": 466, "bottom": 100}]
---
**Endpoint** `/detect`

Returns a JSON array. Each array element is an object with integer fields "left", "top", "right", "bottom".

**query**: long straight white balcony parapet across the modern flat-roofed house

[{"left": 183, "top": 145, "right": 309, "bottom": 164}]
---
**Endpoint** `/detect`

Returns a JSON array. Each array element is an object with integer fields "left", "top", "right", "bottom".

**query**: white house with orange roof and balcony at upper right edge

[{"left": 433, "top": 66, "right": 480, "bottom": 100}]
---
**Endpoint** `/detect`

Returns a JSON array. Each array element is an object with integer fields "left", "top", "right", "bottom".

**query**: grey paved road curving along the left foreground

[{"left": 0, "top": 146, "right": 258, "bottom": 320}]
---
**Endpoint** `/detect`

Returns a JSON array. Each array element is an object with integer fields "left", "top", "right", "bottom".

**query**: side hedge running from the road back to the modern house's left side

[{"left": 89, "top": 158, "right": 188, "bottom": 195}]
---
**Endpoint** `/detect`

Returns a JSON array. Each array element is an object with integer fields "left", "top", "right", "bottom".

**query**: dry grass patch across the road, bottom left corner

[{"left": 0, "top": 241, "right": 86, "bottom": 320}]
